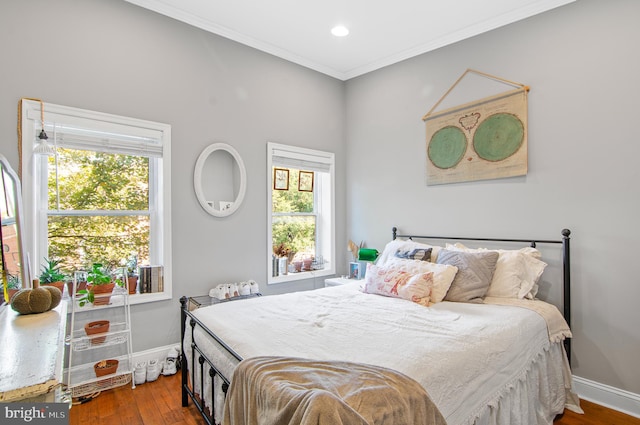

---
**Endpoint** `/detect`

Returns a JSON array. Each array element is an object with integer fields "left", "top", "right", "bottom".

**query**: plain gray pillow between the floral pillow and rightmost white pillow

[{"left": 438, "top": 249, "right": 498, "bottom": 303}]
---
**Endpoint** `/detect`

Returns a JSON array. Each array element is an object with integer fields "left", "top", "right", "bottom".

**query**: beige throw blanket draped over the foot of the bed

[{"left": 223, "top": 357, "right": 446, "bottom": 425}]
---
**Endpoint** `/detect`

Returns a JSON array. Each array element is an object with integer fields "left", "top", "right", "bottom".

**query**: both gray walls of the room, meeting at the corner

[{"left": 0, "top": 0, "right": 640, "bottom": 400}]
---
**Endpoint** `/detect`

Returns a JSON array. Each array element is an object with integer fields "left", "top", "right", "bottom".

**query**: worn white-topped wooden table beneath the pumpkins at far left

[{"left": 0, "top": 300, "right": 67, "bottom": 403}]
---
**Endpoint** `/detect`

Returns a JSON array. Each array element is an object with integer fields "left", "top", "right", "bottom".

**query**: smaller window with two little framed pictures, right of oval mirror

[{"left": 267, "top": 143, "right": 335, "bottom": 283}]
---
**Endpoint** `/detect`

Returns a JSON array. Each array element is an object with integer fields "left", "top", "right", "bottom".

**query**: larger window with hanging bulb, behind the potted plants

[{"left": 21, "top": 101, "right": 171, "bottom": 303}]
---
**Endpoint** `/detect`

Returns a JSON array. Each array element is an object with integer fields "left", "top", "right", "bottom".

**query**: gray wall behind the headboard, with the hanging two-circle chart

[{"left": 346, "top": 0, "right": 640, "bottom": 394}]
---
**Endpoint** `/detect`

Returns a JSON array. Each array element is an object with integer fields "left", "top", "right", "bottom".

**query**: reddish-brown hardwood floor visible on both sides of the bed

[{"left": 69, "top": 373, "right": 640, "bottom": 425}]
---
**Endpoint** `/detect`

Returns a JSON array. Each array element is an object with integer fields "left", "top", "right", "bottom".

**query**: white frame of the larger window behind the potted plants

[{"left": 21, "top": 100, "right": 172, "bottom": 304}]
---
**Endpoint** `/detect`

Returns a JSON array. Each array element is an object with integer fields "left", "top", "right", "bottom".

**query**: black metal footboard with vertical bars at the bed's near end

[{"left": 180, "top": 297, "right": 242, "bottom": 425}]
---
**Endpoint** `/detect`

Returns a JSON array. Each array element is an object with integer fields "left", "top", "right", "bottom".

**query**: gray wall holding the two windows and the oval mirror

[{"left": 0, "top": 0, "right": 345, "bottom": 351}]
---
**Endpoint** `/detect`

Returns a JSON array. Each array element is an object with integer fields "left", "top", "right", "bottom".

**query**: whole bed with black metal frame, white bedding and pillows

[{"left": 181, "top": 228, "right": 580, "bottom": 425}]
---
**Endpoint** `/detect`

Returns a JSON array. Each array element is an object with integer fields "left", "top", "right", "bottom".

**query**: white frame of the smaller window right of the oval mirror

[{"left": 266, "top": 142, "right": 336, "bottom": 284}]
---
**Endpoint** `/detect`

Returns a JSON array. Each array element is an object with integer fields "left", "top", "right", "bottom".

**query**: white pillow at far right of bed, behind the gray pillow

[{"left": 447, "top": 243, "right": 547, "bottom": 299}]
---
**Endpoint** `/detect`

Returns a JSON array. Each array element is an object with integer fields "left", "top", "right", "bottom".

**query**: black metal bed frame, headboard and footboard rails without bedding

[{"left": 180, "top": 227, "right": 571, "bottom": 425}]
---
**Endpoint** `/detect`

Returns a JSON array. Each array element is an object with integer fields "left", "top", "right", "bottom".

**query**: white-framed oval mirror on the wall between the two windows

[{"left": 193, "top": 143, "right": 247, "bottom": 217}]
